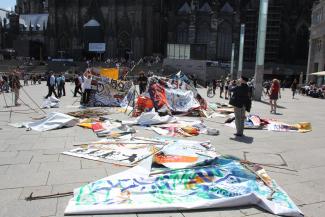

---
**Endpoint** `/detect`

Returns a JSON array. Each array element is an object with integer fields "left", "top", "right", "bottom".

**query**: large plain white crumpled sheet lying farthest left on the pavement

[{"left": 10, "top": 112, "right": 79, "bottom": 132}]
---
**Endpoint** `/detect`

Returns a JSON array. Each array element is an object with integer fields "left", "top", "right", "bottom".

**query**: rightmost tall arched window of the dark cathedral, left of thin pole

[{"left": 217, "top": 22, "right": 232, "bottom": 61}]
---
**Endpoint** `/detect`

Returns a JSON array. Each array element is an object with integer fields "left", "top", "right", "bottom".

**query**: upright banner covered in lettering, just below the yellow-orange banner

[{"left": 87, "top": 76, "right": 134, "bottom": 107}]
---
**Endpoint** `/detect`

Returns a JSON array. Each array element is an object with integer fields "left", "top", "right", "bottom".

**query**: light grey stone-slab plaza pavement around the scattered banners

[{"left": 0, "top": 82, "right": 325, "bottom": 217}]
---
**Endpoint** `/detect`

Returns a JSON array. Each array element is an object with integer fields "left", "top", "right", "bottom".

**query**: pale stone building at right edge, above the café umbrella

[{"left": 307, "top": 0, "right": 325, "bottom": 83}]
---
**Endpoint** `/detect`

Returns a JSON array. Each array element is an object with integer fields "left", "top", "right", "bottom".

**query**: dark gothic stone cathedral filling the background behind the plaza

[{"left": 16, "top": 0, "right": 313, "bottom": 68}]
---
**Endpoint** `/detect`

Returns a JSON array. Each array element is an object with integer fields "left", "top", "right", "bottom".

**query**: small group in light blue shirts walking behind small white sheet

[{"left": 45, "top": 71, "right": 66, "bottom": 98}]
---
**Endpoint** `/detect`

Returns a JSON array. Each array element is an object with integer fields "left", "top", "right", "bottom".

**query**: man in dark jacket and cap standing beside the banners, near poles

[{"left": 229, "top": 77, "right": 252, "bottom": 137}]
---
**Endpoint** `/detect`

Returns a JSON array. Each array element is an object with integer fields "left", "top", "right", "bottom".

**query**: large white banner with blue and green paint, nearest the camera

[{"left": 65, "top": 157, "right": 303, "bottom": 216}]
